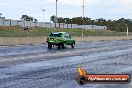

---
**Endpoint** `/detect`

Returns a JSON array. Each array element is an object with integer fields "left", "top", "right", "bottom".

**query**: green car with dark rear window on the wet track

[{"left": 46, "top": 32, "right": 75, "bottom": 49}]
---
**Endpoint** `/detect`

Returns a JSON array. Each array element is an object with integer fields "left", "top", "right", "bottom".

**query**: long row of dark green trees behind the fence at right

[{"left": 51, "top": 15, "right": 132, "bottom": 32}]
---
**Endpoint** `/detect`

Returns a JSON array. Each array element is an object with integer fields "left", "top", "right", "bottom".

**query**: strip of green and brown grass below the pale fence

[{"left": 0, "top": 27, "right": 132, "bottom": 37}]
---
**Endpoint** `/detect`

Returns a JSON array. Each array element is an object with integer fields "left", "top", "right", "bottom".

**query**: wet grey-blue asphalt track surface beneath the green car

[{"left": 0, "top": 40, "right": 132, "bottom": 88}]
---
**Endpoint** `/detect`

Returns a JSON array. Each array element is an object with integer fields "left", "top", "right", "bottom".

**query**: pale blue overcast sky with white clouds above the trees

[{"left": 0, "top": 0, "right": 132, "bottom": 22}]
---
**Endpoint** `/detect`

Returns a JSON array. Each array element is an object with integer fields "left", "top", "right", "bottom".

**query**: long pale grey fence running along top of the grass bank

[{"left": 0, "top": 19, "right": 107, "bottom": 30}]
